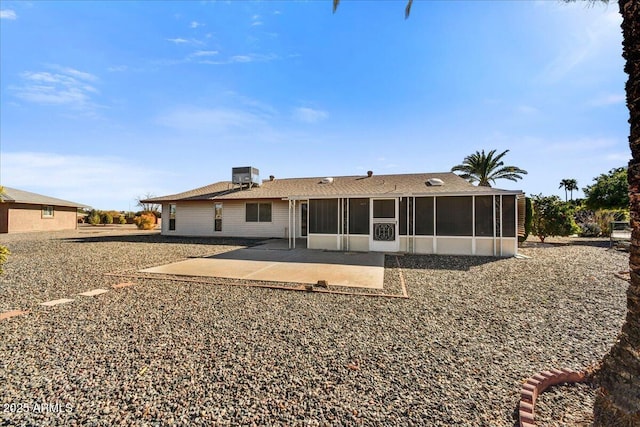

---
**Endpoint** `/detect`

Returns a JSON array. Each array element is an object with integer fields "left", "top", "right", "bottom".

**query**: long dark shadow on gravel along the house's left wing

[{"left": 61, "top": 233, "right": 264, "bottom": 246}]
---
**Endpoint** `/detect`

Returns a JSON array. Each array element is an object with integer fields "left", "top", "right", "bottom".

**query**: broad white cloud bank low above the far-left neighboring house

[{"left": 0, "top": 152, "right": 164, "bottom": 210}]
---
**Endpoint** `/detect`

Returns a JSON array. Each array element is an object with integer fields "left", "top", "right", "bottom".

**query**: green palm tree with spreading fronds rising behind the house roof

[{"left": 451, "top": 150, "right": 527, "bottom": 187}]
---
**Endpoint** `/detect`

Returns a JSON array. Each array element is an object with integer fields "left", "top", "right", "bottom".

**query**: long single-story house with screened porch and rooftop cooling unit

[{"left": 144, "top": 168, "right": 524, "bottom": 256}]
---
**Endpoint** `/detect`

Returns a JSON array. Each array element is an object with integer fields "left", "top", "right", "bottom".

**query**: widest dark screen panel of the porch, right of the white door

[{"left": 436, "top": 196, "right": 473, "bottom": 236}]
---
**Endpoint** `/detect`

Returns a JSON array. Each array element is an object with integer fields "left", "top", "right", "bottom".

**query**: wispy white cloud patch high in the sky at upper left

[{"left": 9, "top": 65, "right": 98, "bottom": 109}]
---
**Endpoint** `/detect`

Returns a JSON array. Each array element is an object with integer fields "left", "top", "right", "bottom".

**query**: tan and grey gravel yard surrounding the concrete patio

[{"left": 0, "top": 231, "right": 628, "bottom": 426}]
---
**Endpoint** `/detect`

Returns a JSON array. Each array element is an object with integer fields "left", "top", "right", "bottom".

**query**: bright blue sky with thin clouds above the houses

[{"left": 0, "top": 0, "right": 630, "bottom": 210}]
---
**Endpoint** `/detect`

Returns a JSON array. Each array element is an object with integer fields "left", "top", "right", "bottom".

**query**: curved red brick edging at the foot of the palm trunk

[{"left": 518, "top": 368, "right": 587, "bottom": 427}]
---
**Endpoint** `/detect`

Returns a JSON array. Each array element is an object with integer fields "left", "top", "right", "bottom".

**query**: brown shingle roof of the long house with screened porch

[{"left": 145, "top": 172, "right": 521, "bottom": 203}]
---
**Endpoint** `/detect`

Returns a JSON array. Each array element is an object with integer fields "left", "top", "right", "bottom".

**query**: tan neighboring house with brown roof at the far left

[{"left": 0, "top": 187, "right": 87, "bottom": 233}]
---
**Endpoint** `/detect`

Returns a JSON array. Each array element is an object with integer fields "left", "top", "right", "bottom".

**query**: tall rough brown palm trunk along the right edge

[{"left": 594, "top": 0, "right": 640, "bottom": 426}]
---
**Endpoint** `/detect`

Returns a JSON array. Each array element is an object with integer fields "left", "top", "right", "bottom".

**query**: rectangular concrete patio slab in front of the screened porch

[{"left": 140, "top": 248, "right": 384, "bottom": 289}]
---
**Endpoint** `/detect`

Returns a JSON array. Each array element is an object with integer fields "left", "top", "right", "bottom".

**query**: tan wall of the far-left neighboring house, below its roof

[{"left": 6, "top": 203, "right": 78, "bottom": 233}]
